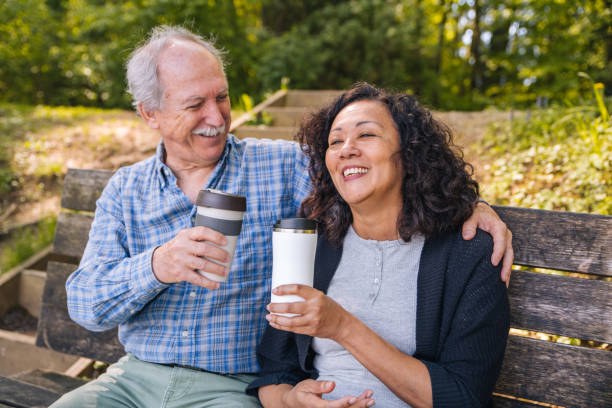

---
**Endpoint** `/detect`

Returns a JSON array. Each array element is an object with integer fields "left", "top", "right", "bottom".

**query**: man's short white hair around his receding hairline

[{"left": 127, "top": 25, "right": 225, "bottom": 112}]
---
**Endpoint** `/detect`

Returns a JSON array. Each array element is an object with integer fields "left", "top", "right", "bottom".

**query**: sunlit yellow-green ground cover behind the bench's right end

[{"left": 480, "top": 83, "right": 612, "bottom": 215}]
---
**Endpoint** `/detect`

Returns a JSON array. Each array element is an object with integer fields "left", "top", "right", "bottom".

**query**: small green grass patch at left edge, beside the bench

[{"left": 0, "top": 217, "right": 57, "bottom": 273}]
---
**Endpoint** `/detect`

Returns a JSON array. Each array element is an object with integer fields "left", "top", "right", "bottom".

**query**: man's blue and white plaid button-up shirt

[{"left": 66, "top": 135, "right": 310, "bottom": 373}]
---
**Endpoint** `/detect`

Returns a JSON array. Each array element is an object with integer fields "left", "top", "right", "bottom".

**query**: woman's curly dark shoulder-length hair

[{"left": 296, "top": 83, "right": 478, "bottom": 246}]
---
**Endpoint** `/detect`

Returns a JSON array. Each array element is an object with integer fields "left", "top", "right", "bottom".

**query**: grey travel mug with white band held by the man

[{"left": 195, "top": 189, "right": 246, "bottom": 282}]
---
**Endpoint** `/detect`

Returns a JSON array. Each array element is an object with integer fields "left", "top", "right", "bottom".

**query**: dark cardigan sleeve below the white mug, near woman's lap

[{"left": 246, "top": 325, "right": 310, "bottom": 397}]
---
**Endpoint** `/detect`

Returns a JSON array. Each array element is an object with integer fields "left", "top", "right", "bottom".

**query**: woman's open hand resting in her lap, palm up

[{"left": 282, "top": 380, "right": 374, "bottom": 408}]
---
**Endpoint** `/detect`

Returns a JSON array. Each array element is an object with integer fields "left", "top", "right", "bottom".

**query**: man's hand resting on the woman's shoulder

[{"left": 463, "top": 202, "right": 514, "bottom": 286}]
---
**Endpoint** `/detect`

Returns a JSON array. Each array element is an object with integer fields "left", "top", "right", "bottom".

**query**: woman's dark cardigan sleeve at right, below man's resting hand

[{"left": 421, "top": 234, "right": 510, "bottom": 407}]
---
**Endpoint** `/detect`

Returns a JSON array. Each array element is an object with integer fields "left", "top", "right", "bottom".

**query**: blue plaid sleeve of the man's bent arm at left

[{"left": 66, "top": 170, "right": 168, "bottom": 331}]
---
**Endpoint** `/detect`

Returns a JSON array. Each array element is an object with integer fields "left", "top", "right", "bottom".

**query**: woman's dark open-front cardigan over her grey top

[{"left": 246, "top": 230, "right": 510, "bottom": 407}]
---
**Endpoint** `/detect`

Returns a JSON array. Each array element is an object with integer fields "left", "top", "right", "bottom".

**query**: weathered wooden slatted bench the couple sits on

[{"left": 0, "top": 169, "right": 612, "bottom": 407}]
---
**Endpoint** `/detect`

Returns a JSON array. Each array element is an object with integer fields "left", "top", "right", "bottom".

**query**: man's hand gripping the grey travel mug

[{"left": 151, "top": 227, "right": 229, "bottom": 289}]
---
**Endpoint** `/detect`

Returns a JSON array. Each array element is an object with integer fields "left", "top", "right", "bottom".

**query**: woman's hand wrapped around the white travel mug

[{"left": 266, "top": 285, "right": 353, "bottom": 341}]
